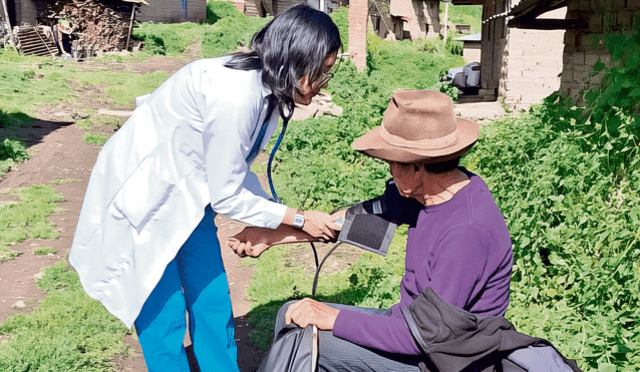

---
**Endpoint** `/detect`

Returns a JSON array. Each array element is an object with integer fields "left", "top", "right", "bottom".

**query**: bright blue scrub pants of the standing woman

[{"left": 135, "top": 206, "right": 238, "bottom": 372}]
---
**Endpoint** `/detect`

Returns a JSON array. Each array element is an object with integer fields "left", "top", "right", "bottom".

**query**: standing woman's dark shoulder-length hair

[{"left": 225, "top": 4, "right": 342, "bottom": 120}]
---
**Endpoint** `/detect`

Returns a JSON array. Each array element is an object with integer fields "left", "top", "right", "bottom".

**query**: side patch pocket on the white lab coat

[{"left": 113, "top": 157, "right": 175, "bottom": 231}]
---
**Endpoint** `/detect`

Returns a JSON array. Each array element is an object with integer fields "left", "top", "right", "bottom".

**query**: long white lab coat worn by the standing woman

[{"left": 69, "top": 57, "right": 286, "bottom": 327}]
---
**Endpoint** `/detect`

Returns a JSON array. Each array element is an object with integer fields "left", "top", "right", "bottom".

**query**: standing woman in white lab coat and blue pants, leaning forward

[{"left": 69, "top": 5, "right": 341, "bottom": 372}]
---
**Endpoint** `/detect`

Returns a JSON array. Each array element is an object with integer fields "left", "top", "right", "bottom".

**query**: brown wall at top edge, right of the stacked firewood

[{"left": 136, "top": 0, "right": 207, "bottom": 23}]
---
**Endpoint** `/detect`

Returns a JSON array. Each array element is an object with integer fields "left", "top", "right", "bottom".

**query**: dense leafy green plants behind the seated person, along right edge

[{"left": 467, "top": 26, "right": 640, "bottom": 371}]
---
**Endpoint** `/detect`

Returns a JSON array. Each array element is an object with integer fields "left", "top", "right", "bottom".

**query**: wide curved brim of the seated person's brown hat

[{"left": 352, "top": 118, "right": 480, "bottom": 163}]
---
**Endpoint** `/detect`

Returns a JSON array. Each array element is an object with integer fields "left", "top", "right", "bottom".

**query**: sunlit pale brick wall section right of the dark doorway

[{"left": 503, "top": 8, "right": 567, "bottom": 105}]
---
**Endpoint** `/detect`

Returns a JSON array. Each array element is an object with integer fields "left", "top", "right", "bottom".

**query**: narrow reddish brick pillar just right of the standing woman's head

[{"left": 349, "top": 0, "right": 369, "bottom": 71}]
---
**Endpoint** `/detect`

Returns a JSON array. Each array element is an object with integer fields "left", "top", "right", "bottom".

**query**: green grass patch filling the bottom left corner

[{"left": 0, "top": 262, "right": 130, "bottom": 372}]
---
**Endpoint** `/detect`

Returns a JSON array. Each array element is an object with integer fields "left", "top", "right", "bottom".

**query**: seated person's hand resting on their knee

[{"left": 284, "top": 298, "right": 340, "bottom": 331}]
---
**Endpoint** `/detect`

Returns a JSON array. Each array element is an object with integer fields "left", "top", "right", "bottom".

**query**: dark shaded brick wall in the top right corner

[{"left": 560, "top": 0, "right": 640, "bottom": 96}]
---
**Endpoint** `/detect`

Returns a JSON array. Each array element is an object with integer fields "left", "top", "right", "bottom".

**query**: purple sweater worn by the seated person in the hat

[{"left": 333, "top": 168, "right": 513, "bottom": 355}]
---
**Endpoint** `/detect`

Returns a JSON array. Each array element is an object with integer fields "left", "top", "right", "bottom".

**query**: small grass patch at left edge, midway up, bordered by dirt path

[{"left": 0, "top": 185, "right": 63, "bottom": 262}]
